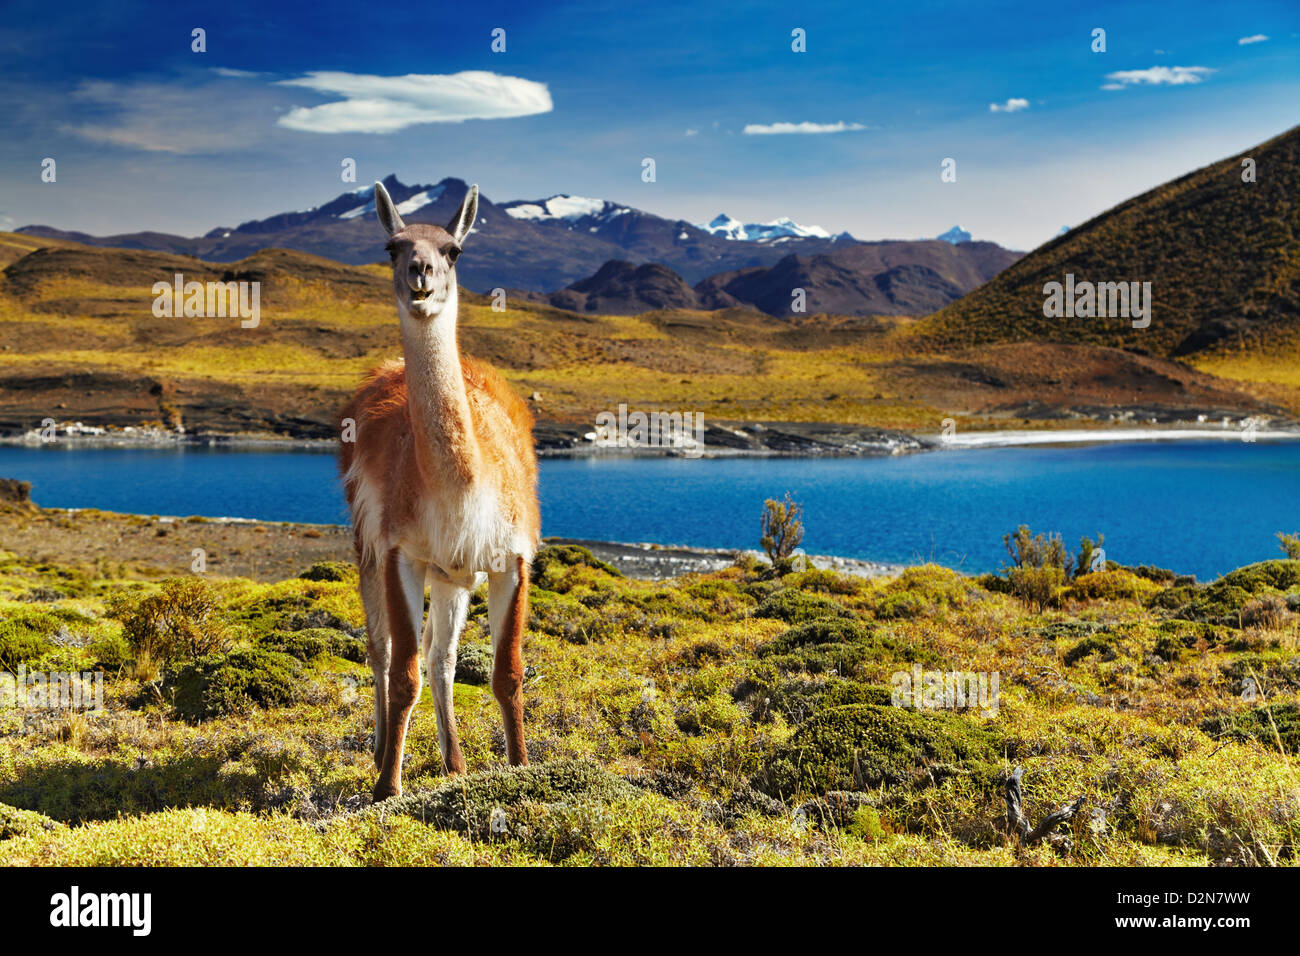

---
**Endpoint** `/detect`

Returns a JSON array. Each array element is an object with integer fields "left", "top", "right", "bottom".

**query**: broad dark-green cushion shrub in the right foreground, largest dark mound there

[{"left": 753, "top": 704, "right": 998, "bottom": 797}]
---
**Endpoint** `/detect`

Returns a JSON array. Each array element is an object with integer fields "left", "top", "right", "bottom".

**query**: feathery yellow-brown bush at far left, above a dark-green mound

[{"left": 108, "top": 578, "right": 233, "bottom": 662}]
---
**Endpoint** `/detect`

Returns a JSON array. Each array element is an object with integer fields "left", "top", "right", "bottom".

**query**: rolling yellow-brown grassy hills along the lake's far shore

[{"left": 0, "top": 234, "right": 1279, "bottom": 437}]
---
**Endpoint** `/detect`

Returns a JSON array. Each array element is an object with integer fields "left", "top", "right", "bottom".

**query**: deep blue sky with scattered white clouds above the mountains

[{"left": 0, "top": 0, "right": 1300, "bottom": 248}]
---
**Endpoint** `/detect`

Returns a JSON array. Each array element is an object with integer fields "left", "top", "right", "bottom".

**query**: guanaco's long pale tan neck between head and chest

[{"left": 402, "top": 282, "right": 478, "bottom": 484}]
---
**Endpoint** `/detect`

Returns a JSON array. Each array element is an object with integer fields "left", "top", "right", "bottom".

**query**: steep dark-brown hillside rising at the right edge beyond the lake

[{"left": 917, "top": 127, "right": 1300, "bottom": 366}]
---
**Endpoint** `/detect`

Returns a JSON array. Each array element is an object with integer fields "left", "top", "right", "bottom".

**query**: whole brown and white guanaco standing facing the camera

[{"left": 339, "top": 183, "right": 541, "bottom": 800}]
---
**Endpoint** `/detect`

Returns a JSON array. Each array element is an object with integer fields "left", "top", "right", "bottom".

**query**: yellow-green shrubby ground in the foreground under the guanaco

[{"left": 0, "top": 538, "right": 1300, "bottom": 866}]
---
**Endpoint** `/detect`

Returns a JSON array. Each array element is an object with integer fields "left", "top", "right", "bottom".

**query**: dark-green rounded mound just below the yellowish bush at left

[{"left": 164, "top": 649, "right": 302, "bottom": 721}]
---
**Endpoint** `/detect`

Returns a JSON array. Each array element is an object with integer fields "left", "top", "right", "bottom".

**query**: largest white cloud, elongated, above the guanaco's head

[{"left": 277, "top": 70, "right": 553, "bottom": 133}]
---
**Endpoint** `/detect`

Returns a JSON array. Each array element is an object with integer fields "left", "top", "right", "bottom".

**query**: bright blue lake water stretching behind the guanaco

[{"left": 0, "top": 441, "right": 1300, "bottom": 580}]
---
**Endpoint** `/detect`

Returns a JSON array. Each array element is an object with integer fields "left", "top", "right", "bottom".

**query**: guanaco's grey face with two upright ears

[{"left": 374, "top": 182, "right": 478, "bottom": 319}]
